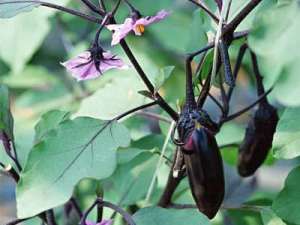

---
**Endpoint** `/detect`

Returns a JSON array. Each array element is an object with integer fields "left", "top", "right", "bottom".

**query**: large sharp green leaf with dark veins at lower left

[{"left": 17, "top": 117, "right": 130, "bottom": 218}]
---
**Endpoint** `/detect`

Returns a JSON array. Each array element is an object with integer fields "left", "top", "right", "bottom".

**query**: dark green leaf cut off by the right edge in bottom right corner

[{"left": 272, "top": 167, "right": 300, "bottom": 224}]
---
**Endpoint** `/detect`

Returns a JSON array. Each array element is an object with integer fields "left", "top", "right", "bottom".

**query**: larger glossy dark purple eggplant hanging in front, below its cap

[{"left": 182, "top": 127, "right": 225, "bottom": 219}]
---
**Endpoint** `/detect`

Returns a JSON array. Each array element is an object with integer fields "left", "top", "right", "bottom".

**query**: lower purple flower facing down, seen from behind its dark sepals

[{"left": 61, "top": 50, "right": 128, "bottom": 81}]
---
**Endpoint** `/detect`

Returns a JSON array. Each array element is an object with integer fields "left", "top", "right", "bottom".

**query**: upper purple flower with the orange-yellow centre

[{"left": 106, "top": 10, "right": 170, "bottom": 45}]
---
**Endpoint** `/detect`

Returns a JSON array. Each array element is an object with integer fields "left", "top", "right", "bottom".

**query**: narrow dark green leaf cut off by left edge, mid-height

[{"left": 0, "top": 84, "right": 14, "bottom": 140}]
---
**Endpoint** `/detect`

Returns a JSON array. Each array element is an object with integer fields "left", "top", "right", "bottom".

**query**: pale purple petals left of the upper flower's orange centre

[{"left": 106, "top": 18, "right": 134, "bottom": 45}]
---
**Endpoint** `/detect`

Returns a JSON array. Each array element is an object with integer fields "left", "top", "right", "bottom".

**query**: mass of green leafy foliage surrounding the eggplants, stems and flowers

[{"left": 0, "top": 0, "right": 300, "bottom": 225}]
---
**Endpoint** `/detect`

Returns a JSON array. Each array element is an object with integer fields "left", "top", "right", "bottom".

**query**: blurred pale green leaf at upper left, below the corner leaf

[{"left": 0, "top": 10, "right": 50, "bottom": 73}]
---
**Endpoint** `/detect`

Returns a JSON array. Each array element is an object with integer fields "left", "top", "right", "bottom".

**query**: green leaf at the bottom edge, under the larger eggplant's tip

[{"left": 133, "top": 207, "right": 210, "bottom": 225}]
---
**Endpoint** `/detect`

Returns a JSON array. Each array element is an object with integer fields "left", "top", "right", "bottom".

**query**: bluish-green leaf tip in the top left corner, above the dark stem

[{"left": 0, "top": 0, "right": 40, "bottom": 18}]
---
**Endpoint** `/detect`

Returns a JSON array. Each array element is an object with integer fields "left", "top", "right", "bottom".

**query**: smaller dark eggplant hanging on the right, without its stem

[{"left": 238, "top": 100, "right": 279, "bottom": 177}]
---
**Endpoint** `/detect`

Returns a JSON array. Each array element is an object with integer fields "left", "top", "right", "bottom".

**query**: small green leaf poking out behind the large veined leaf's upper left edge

[{"left": 35, "top": 110, "right": 70, "bottom": 142}]
